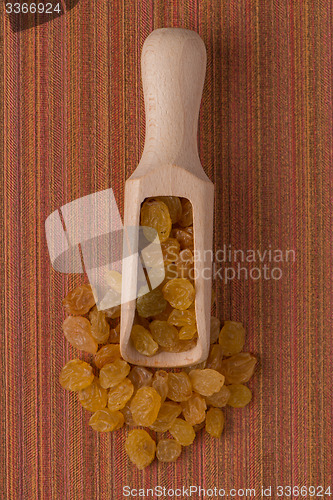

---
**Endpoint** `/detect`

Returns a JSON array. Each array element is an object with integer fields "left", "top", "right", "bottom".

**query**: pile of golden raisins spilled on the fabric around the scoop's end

[{"left": 59, "top": 280, "right": 256, "bottom": 469}]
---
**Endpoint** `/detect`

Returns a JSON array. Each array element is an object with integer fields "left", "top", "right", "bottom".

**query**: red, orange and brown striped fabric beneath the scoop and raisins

[{"left": 0, "top": 0, "right": 333, "bottom": 500}]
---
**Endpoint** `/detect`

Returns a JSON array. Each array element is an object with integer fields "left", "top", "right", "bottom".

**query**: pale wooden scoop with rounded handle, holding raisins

[{"left": 120, "top": 28, "right": 214, "bottom": 367}]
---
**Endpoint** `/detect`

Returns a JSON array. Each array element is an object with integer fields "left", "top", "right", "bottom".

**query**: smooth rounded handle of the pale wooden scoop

[{"left": 140, "top": 28, "right": 206, "bottom": 172}]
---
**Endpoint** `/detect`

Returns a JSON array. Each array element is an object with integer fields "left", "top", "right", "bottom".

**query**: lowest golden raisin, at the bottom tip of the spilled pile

[{"left": 125, "top": 429, "right": 156, "bottom": 470}]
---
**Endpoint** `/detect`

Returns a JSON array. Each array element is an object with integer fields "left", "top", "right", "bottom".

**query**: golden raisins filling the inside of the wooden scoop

[{"left": 131, "top": 196, "right": 197, "bottom": 356}]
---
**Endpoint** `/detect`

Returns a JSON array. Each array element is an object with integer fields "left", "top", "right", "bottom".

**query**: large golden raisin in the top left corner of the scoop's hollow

[{"left": 141, "top": 199, "right": 172, "bottom": 242}]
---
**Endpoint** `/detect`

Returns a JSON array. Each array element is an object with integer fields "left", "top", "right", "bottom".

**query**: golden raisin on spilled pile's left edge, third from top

[{"left": 59, "top": 359, "right": 94, "bottom": 391}]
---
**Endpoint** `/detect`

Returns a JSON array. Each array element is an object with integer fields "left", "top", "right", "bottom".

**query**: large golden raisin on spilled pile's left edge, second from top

[{"left": 62, "top": 316, "right": 98, "bottom": 354}]
